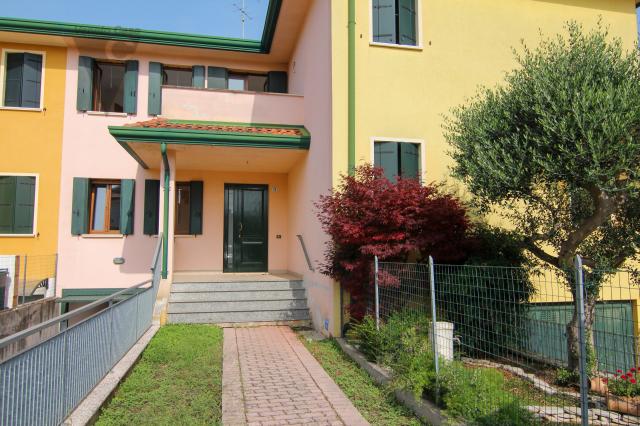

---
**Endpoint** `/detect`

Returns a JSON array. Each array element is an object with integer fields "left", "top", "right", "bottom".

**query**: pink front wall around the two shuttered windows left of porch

[{"left": 58, "top": 44, "right": 302, "bottom": 293}]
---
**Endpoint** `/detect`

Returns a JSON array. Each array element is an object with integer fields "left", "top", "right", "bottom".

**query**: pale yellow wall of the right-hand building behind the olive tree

[{"left": 332, "top": 0, "right": 640, "bottom": 328}]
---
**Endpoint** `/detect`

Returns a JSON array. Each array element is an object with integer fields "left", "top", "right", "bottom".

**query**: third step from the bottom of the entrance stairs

[{"left": 169, "top": 289, "right": 306, "bottom": 303}]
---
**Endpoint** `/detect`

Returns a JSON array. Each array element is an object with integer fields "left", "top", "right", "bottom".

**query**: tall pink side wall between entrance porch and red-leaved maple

[{"left": 289, "top": 0, "right": 340, "bottom": 333}]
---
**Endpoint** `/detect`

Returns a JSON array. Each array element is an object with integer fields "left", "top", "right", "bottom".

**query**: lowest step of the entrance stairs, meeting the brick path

[{"left": 167, "top": 309, "right": 310, "bottom": 324}]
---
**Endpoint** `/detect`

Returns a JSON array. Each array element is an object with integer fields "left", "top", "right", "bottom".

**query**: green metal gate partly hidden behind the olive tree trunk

[{"left": 526, "top": 302, "right": 636, "bottom": 372}]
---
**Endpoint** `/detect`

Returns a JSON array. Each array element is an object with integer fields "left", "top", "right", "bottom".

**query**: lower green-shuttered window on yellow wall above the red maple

[{"left": 373, "top": 141, "right": 421, "bottom": 182}]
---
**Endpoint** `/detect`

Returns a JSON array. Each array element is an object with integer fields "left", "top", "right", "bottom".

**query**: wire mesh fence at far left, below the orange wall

[{"left": 0, "top": 254, "right": 58, "bottom": 310}]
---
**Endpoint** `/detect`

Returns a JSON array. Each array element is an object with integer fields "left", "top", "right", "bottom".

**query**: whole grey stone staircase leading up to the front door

[{"left": 167, "top": 280, "right": 310, "bottom": 325}]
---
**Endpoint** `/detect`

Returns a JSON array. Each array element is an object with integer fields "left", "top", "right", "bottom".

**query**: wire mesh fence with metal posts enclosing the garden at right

[{"left": 360, "top": 262, "right": 640, "bottom": 424}]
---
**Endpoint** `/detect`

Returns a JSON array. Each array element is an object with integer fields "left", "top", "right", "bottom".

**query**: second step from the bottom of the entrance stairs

[{"left": 168, "top": 299, "right": 307, "bottom": 314}]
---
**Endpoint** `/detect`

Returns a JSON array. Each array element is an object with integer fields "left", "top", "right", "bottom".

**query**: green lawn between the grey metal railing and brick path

[{"left": 96, "top": 325, "right": 222, "bottom": 426}]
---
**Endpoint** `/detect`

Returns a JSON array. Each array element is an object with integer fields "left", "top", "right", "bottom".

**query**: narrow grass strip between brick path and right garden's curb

[{"left": 301, "top": 338, "right": 421, "bottom": 426}]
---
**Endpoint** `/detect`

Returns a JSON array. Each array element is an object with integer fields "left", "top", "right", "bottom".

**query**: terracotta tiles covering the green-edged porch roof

[{"left": 126, "top": 118, "right": 303, "bottom": 136}]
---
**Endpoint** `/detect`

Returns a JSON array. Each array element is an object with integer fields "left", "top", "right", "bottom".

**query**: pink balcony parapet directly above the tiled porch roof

[{"left": 162, "top": 87, "right": 304, "bottom": 124}]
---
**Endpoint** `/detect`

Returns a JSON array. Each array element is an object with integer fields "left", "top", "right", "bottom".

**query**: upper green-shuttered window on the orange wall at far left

[{"left": 3, "top": 52, "right": 43, "bottom": 108}]
